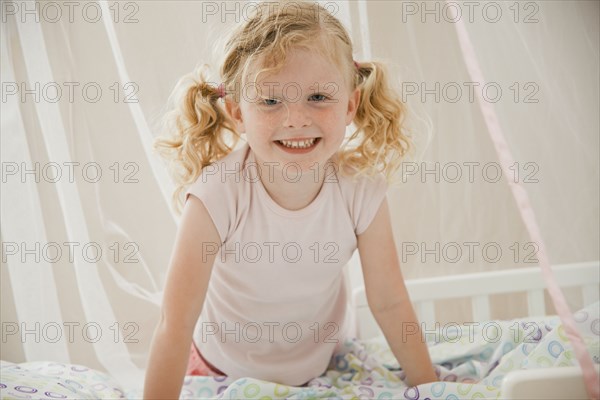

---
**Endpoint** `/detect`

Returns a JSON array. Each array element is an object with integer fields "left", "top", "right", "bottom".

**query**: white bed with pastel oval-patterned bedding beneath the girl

[{"left": 0, "top": 262, "right": 600, "bottom": 400}]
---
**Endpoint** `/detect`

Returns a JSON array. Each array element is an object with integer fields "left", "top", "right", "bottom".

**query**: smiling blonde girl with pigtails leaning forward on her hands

[{"left": 144, "top": 2, "right": 437, "bottom": 399}]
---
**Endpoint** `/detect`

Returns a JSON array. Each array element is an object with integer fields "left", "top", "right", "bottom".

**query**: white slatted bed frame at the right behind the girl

[{"left": 352, "top": 261, "right": 600, "bottom": 400}]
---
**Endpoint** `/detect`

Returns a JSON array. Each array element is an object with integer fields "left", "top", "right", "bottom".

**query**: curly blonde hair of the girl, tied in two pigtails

[{"left": 155, "top": 1, "right": 410, "bottom": 212}]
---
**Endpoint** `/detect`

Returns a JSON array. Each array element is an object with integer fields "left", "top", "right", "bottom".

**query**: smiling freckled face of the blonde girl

[{"left": 227, "top": 49, "right": 360, "bottom": 171}]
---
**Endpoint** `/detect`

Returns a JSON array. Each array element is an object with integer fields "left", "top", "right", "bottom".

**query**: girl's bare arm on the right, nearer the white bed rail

[{"left": 358, "top": 199, "right": 438, "bottom": 386}]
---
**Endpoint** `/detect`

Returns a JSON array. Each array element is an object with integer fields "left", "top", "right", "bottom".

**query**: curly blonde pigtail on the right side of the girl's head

[{"left": 339, "top": 61, "right": 411, "bottom": 182}]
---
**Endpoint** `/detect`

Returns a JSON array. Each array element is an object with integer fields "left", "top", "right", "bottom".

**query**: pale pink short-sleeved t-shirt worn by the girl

[{"left": 186, "top": 143, "right": 387, "bottom": 386}]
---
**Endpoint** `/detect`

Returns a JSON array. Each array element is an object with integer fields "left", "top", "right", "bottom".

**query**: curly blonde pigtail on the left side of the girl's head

[{"left": 154, "top": 65, "right": 240, "bottom": 213}]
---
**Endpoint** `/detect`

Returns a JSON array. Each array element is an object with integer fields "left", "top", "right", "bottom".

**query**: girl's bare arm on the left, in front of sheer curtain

[{"left": 144, "top": 196, "right": 221, "bottom": 400}]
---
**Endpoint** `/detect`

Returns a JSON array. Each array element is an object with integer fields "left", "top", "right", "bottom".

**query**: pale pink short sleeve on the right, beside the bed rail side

[{"left": 351, "top": 173, "right": 388, "bottom": 236}]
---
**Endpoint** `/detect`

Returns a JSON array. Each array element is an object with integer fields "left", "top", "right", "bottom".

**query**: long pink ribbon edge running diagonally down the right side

[{"left": 446, "top": 0, "right": 600, "bottom": 400}]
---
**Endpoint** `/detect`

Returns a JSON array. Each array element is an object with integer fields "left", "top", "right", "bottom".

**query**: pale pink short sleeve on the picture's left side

[{"left": 185, "top": 169, "right": 236, "bottom": 244}]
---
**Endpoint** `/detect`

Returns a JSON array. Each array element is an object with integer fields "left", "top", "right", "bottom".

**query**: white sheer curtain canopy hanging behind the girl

[{"left": 1, "top": 1, "right": 600, "bottom": 386}]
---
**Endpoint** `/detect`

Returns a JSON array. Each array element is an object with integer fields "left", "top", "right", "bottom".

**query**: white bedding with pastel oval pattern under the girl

[{"left": 0, "top": 303, "right": 600, "bottom": 400}]
